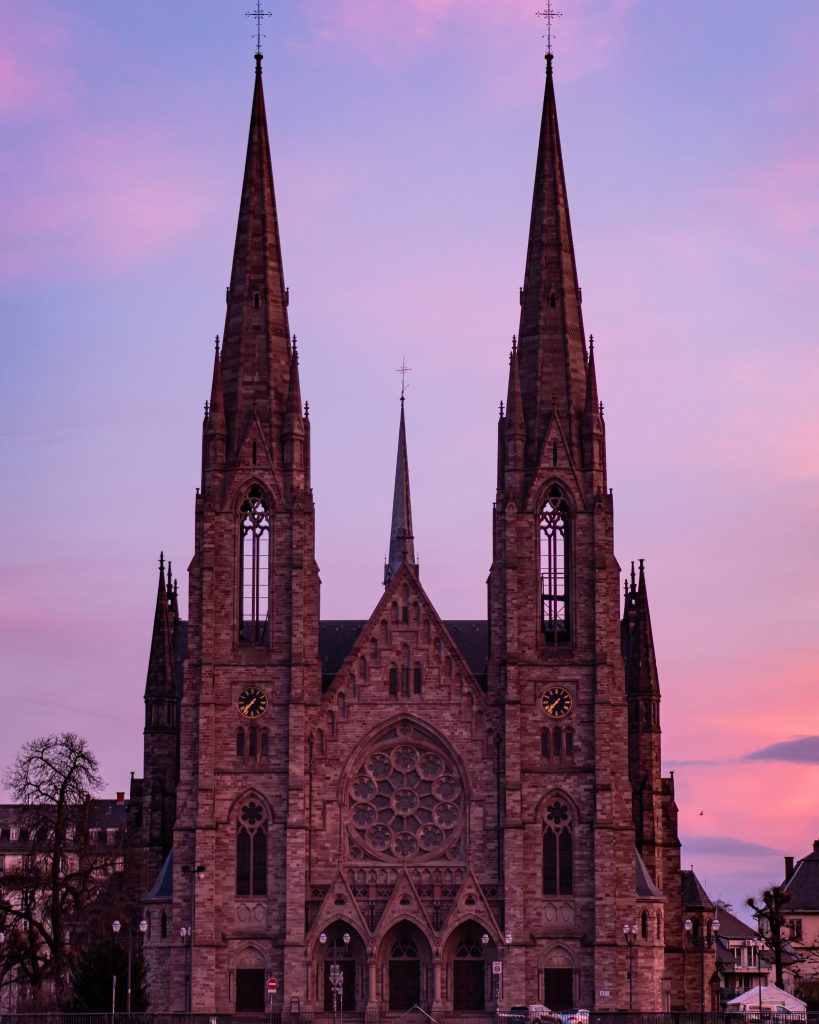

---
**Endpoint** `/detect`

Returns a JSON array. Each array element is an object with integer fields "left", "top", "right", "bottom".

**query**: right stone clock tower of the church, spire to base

[{"left": 488, "top": 54, "right": 662, "bottom": 1010}]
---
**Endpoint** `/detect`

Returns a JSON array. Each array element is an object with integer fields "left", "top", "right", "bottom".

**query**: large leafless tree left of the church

[{"left": 0, "top": 732, "right": 112, "bottom": 1005}]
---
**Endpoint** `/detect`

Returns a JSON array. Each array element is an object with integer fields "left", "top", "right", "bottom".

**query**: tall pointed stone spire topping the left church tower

[{"left": 221, "top": 53, "right": 290, "bottom": 454}]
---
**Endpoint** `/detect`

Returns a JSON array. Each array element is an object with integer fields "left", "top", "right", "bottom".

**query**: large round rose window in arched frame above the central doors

[{"left": 346, "top": 725, "right": 465, "bottom": 861}]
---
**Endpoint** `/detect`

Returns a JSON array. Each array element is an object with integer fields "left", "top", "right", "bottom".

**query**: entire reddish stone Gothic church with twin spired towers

[{"left": 132, "top": 46, "right": 709, "bottom": 1015}]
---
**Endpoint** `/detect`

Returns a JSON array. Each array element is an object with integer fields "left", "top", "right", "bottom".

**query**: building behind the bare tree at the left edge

[{"left": 0, "top": 794, "right": 127, "bottom": 1013}]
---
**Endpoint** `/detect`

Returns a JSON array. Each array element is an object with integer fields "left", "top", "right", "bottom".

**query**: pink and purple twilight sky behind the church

[{"left": 0, "top": 0, "right": 819, "bottom": 921}]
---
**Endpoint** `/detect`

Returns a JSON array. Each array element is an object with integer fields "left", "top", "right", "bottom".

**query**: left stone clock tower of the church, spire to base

[{"left": 169, "top": 55, "right": 320, "bottom": 1011}]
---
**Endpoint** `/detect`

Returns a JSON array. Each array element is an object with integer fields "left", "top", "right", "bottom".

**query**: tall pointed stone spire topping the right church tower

[{"left": 518, "top": 53, "right": 586, "bottom": 467}]
